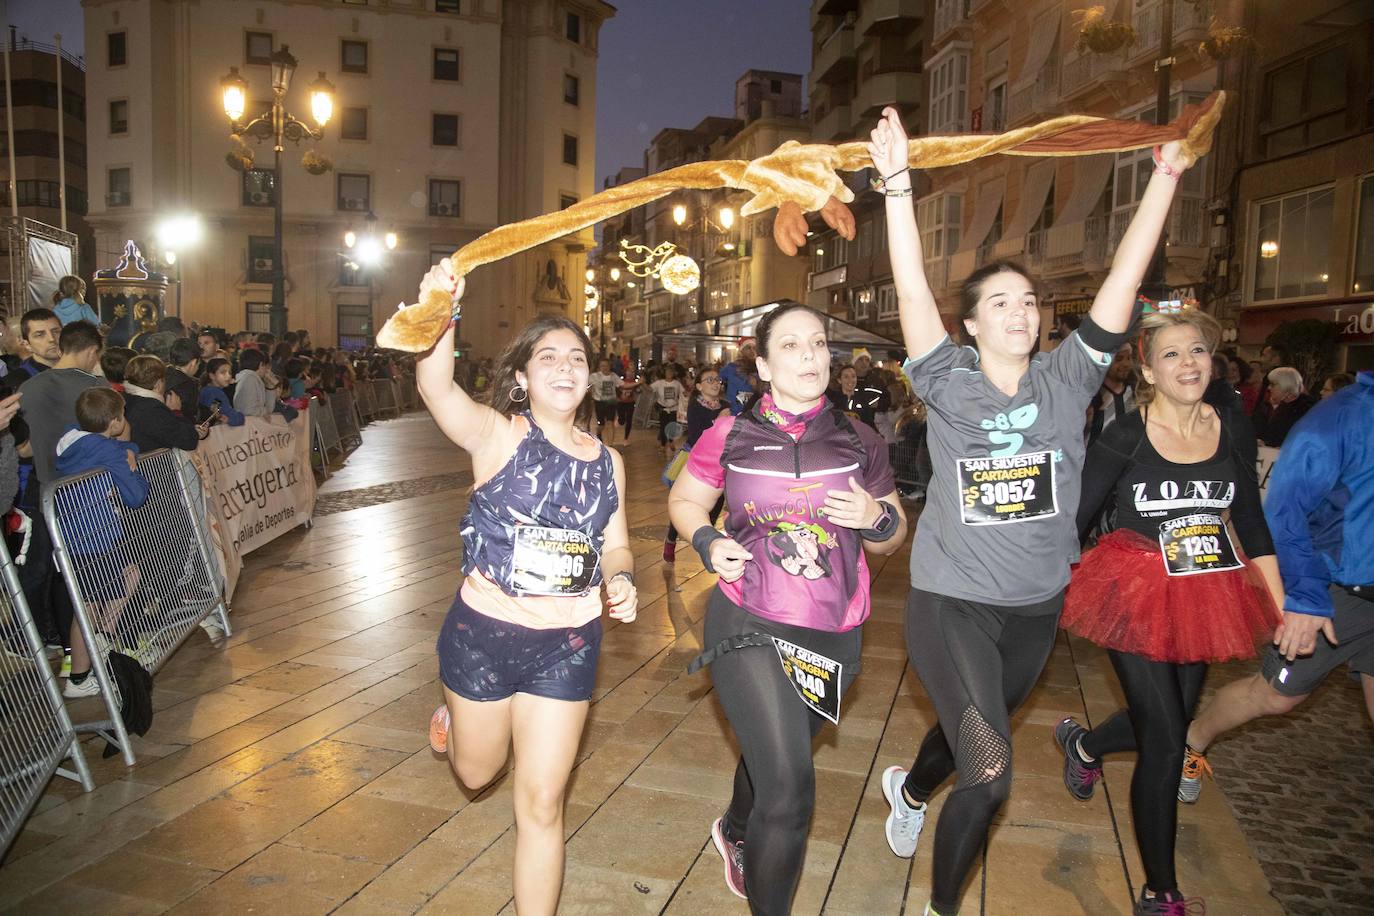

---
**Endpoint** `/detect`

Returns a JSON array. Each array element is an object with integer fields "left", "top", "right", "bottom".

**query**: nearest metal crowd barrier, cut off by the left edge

[{"left": 0, "top": 538, "right": 95, "bottom": 854}]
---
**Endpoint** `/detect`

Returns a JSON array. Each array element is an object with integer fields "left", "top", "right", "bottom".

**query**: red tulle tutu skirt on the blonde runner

[{"left": 1059, "top": 529, "right": 1281, "bottom": 663}]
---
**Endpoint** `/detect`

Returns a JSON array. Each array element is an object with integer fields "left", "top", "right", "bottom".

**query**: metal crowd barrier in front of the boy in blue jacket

[{"left": 43, "top": 449, "right": 231, "bottom": 766}]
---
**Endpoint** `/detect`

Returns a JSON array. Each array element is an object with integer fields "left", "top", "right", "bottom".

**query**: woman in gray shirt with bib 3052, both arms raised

[{"left": 868, "top": 100, "right": 1198, "bottom": 916}]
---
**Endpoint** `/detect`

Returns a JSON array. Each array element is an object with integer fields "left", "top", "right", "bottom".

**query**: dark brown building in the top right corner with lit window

[{"left": 1217, "top": 0, "right": 1374, "bottom": 373}]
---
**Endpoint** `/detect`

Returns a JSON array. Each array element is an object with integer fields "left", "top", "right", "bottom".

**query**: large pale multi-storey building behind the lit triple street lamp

[{"left": 84, "top": 0, "right": 614, "bottom": 356}]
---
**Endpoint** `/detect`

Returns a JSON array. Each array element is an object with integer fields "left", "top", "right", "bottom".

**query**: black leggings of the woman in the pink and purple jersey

[{"left": 706, "top": 589, "right": 857, "bottom": 916}]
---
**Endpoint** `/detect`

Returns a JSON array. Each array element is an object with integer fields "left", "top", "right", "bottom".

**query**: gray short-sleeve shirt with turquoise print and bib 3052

[{"left": 903, "top": 334, "right": 1112, "bottom": 606}]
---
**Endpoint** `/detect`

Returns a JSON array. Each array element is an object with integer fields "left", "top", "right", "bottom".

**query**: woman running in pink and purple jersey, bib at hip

[{"left": 668, "top": 304, "right": 907, "bottom": 916}]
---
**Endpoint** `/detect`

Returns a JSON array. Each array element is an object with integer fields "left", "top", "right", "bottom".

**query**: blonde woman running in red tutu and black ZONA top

[{"left": 1054, "top": 309, "right": 1283, "bottom": 916}]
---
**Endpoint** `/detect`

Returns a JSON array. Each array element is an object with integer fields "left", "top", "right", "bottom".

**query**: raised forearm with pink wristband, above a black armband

[{"left": 1088, "top": 140, "right": 1189, "bottom": 334}]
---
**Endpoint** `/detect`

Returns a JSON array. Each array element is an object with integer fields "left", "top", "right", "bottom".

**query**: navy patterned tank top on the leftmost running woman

[{"left": 462, "top": 411, "right": 620, "bottom": 597}]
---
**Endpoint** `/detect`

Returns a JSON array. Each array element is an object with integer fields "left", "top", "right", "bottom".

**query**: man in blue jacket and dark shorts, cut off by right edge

[{"left": 1179, "top": 371, "right": 1374, "bottom": 802}]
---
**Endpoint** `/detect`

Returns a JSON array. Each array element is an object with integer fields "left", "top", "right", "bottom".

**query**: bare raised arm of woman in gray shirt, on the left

[{"left": 867, "top": 108, "right": 945, "bottom": 357}]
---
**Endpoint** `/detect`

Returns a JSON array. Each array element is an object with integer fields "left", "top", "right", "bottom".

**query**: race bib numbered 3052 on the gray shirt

[{"left": 958, "top": 452, "right": 1059, "bottom": 525}]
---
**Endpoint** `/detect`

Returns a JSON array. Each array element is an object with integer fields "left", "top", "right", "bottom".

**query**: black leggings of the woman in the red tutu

[{"left": 1083, "top": 650, "right": 1206, "bottom": 894}]
